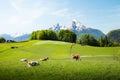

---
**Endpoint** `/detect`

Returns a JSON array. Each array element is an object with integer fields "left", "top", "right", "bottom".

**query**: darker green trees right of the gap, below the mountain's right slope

[{"left": 77, "top": 34, "right": 119, "bottom": 47}]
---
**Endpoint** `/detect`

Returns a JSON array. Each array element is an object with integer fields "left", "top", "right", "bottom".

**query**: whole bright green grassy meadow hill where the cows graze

[{"left": 0, "top": 40, "right": 120, "bottom": 80}]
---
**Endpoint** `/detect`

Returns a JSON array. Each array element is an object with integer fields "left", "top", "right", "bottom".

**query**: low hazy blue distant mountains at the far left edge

[{"left": 0, "top": 34, "right": 30, "bottom": 41}]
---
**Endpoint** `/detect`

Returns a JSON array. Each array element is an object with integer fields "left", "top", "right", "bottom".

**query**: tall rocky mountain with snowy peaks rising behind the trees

[{"left": 49, "top": 20, "right": 105, "bottom": 39}]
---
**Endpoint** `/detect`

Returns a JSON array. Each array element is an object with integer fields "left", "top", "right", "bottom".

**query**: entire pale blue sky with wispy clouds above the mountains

[{"left": 0, "top": 0, "right": 120, "bottom": 34}]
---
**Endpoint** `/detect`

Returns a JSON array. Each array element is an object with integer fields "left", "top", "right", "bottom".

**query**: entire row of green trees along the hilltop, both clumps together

[{"left": 30, "top": 30, "right": 118, "bottom": 47}]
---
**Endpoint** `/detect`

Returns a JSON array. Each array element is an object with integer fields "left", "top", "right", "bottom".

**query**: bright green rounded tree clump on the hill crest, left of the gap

[{"left": 30, "top": 30, "right": 76, "bottom": 43}]
